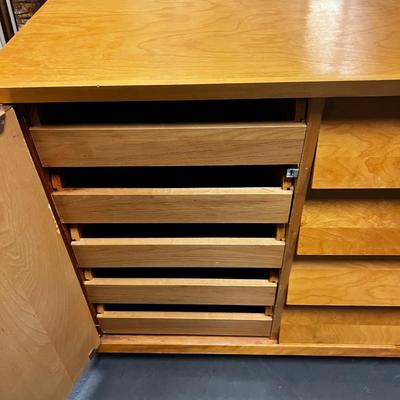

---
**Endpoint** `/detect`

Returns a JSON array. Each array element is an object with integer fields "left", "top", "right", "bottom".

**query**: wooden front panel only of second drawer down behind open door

[{"left": 53, "top": 188, "right": 292, "bottom": 223}]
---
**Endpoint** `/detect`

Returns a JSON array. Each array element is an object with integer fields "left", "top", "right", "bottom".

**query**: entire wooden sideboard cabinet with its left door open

[{"left": 0, "top": 0, "right": 400, "bottom": 400}]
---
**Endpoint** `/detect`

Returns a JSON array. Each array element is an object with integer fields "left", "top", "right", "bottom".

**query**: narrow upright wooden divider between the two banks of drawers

[{"left": 271, "top": 99, "right": 324, "bottom": 339}]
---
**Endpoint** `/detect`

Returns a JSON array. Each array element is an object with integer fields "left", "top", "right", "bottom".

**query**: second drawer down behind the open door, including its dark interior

[{"left": 53, "top": 166, "right": 292, "bottom": 223}]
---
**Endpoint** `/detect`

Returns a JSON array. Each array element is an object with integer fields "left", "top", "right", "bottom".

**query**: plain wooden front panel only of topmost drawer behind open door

[{"left": 30, "top": 122, "right": 305, "bottom": 167}]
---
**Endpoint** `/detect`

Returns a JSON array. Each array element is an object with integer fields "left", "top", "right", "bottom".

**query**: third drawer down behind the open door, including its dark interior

[{"left": 72, "top": 224, "right": 285, "bottom": 268}]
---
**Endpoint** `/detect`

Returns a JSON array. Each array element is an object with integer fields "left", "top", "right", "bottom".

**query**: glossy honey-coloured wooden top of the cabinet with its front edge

[{"left": 0, "top": 0, "right": 400, "bottom": 103}]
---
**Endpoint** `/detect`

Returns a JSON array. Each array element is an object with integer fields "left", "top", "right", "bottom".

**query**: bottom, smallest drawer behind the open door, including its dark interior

[{"left": 97, "top": 304, "right": 272, "bottom": 337}]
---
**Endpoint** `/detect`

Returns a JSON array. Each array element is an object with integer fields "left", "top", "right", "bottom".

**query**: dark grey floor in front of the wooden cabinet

[{"left": 69, "top": 354, "right": 400, "bottom": 400}]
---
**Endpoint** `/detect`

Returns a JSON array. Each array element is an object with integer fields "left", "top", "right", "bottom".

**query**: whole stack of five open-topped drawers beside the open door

[{"left": 30, "top": 100, "right": 305, "bottom": 337}]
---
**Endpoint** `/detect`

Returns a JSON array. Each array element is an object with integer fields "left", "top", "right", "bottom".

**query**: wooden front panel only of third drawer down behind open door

[{"left": 72, "top": 238, "right": 285, "bottom": 268}]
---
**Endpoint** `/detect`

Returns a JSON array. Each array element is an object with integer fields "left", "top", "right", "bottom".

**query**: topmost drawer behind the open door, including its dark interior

[{"left": 30, "top": 100, "right": 305, "bottom": 167}]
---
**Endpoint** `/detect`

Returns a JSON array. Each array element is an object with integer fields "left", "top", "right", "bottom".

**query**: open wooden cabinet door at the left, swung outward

[{"left": 0, "top": 108, "right": 99, "bottom": 400}]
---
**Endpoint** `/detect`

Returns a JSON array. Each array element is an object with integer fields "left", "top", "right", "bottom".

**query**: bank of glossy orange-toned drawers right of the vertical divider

[{"left": 280, "top": 98, "right": 400, "bottom": 345}]
